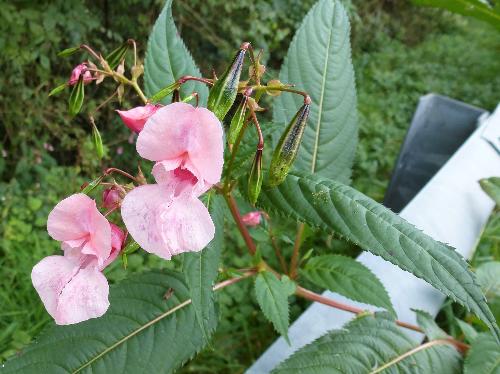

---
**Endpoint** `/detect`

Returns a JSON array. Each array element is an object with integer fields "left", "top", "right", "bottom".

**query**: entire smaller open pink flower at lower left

[{"left": 31, "top": 194, "right": 125, "bottom": 325}]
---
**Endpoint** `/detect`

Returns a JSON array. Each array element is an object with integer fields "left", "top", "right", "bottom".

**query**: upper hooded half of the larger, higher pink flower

[{"left": 136, "top": 103, "right": 224, "bottom": 196}]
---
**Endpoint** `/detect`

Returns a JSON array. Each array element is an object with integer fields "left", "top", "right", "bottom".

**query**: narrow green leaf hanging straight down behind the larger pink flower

[{"left": 182, "top": 193, "right": 224, "bottom": 342}]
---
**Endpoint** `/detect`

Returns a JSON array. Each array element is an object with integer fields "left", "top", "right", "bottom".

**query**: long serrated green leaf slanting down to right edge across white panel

[{"left": 259, "top": 173, "right": 500, "bottom": 337}]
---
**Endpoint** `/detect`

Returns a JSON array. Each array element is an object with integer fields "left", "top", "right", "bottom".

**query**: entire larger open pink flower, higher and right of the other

[{"left": 121, "top": 103, "right": 223, "bottom": 259}]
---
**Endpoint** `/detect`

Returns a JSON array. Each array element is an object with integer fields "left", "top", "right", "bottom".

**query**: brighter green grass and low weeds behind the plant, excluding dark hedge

[{"left": 0, "top": 12, "right": 500, "bottom": 373}]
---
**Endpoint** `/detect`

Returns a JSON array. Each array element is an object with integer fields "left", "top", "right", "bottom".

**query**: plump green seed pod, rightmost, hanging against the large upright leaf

[{"left": 269, "top": 98, "right": 310, "bottom": 187}]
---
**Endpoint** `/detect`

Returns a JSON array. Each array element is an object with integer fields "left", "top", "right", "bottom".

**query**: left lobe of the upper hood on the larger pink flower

[{"left": 136, "top": 103, "right": 196, "bottom": 161}]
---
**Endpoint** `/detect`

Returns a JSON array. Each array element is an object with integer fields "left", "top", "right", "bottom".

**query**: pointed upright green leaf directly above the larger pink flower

[{"left": 144, "top": 0, "right": 208, "bottom": 106}]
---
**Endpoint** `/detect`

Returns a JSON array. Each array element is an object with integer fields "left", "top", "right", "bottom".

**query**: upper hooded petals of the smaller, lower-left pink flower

[{"left": 47, "top": 193, "right": 111, "bottom": 264}]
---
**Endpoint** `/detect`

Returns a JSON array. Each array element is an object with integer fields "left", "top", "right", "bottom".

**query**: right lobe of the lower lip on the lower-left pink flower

[{"left": 53, "top": 266, "right": 109, "bottom": 325}]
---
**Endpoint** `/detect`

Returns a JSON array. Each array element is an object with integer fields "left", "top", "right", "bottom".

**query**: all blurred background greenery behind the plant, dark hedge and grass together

[{"left": 0, "top": 0, "right": 500, "bottom": 373}]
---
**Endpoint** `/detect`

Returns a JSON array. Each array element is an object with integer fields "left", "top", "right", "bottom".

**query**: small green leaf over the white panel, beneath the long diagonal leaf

[{"left": 301, "top": 255, "right": 396, "bottom": 315}]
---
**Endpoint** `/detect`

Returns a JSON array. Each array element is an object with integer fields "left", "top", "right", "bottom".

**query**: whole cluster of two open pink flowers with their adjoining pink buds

[{"left": 31, "top": 102, "right": 223, "bottom": 325}]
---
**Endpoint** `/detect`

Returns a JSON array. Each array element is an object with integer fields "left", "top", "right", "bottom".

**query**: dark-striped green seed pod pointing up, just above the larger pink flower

[{"left": 207, "top": 43, "right": 250, "bottom": 121}]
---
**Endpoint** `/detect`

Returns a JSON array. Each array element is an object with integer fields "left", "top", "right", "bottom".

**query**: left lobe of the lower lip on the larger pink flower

[{"left": 121, "top": 184, "right": 173, "bottom": 258}]
